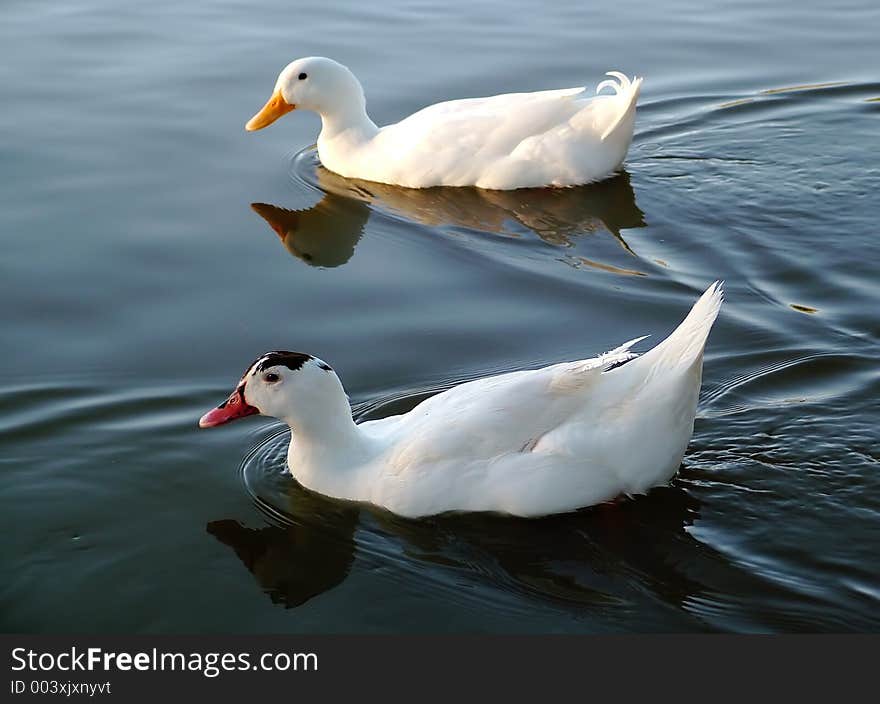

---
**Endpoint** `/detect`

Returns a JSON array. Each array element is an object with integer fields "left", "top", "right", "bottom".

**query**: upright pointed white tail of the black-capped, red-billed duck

[{"left": 634, "top": 281, "right": 724, "bottom": 374}]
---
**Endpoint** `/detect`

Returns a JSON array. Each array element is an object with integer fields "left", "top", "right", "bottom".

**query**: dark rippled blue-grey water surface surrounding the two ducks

[{"left": 0, "top": 0, "right": 880, "bottom": 632}]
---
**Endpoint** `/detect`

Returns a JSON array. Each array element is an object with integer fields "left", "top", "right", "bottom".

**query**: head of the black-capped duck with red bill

[{"left": 199, "top": 352, "right": 351, "bottom": 432}]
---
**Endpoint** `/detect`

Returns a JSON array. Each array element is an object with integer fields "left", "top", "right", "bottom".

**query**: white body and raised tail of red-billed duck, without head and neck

[{"left": 364, "top": 284, "right": 722, "bottom": 516}]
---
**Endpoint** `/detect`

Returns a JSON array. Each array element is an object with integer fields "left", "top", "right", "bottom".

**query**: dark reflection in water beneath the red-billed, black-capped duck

[{"left": 207, "top": 467, "right": 810, "bottom": 631}]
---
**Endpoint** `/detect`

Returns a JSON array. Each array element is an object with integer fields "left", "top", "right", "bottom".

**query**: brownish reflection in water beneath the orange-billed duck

[{"left": 251, "top": 166, "right": 645, "bottom": 273}]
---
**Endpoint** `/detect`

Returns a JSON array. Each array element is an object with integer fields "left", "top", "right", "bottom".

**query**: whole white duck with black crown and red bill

[{"left": 199, "top": 282, "right": 722, "bottom": 517}]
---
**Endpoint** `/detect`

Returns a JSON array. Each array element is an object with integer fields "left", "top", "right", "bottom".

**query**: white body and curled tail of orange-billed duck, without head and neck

[{"left": 369, "top": 74, "right": 641, "bottom": 189}]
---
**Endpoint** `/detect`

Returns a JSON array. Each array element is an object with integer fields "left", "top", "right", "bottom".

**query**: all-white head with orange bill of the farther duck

[{"left": 245, "top": 56, "right": 366, "bottom": 132}]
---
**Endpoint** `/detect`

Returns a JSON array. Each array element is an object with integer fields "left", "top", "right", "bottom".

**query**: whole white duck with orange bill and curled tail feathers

[{"left": 245, "top": 56, "right": 642, "bottom": 190}]
